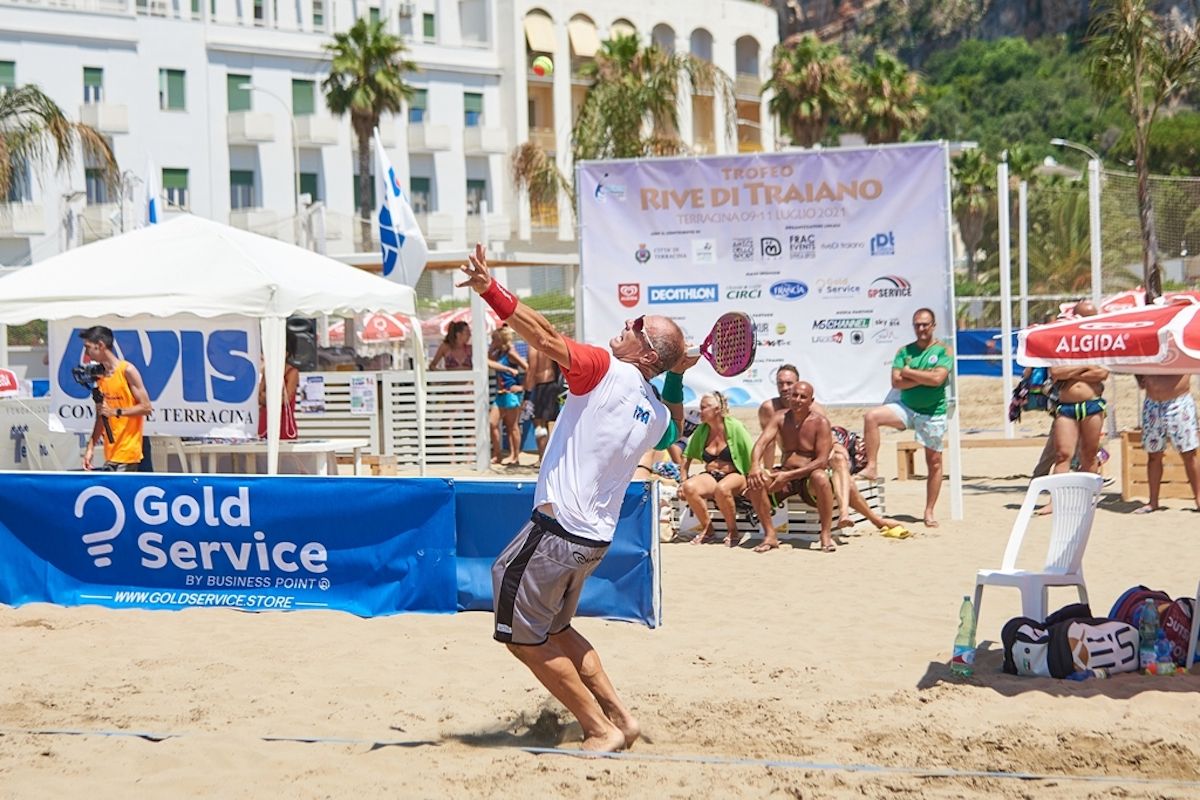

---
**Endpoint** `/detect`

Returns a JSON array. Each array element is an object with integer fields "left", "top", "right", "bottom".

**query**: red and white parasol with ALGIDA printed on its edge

[{"left": 1016, "top": 293, "right": 1200, "bottom": 374}]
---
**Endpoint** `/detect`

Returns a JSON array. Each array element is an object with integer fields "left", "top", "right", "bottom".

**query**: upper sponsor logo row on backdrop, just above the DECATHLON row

[{"left": 634, "top": 230, "right": 896, "bottom": 264}]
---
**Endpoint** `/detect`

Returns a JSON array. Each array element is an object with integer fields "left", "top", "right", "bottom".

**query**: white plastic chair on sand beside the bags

[{"left": 974, "top": 473, "right": 1104, "bottom": 622}]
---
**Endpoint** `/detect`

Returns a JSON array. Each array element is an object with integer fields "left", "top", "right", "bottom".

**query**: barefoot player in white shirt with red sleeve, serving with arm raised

[{"left": 458, "top": 245, "right": 758, "bottom": 751}]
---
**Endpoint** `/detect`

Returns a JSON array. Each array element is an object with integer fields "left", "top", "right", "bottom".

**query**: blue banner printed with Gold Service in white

[{"left": 0, "top": 473, "right": 456, "bottom": 616}]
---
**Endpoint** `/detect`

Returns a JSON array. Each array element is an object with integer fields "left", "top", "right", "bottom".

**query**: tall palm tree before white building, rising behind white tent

[{"left": 322, "top": 17, "right": 416, "bottom": 245}]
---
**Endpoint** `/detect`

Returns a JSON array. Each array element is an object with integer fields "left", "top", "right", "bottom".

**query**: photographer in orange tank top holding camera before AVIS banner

[{"left": 79, "top": 325, "right": 152, "bottom": 473}]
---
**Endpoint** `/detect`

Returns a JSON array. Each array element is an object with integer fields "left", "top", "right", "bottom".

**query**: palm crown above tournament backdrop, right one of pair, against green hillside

[{"left": 847, "top": 50, "right": 929, "bottom": 144}]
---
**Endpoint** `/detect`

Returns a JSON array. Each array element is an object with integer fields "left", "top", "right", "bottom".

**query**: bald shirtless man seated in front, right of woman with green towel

[{"left": 746, "top": 380, "right": 838, "bottom": 553}]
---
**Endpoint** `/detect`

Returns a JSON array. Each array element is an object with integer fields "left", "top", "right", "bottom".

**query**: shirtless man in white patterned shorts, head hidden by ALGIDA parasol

[{"left": 1134, "top": 375, "right": 1200, "bottom": 513}]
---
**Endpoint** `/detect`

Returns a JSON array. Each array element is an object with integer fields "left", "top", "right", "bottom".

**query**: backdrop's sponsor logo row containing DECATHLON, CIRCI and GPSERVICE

[{"left": 617, "top": 275, "right": 912, "bottom": 308}]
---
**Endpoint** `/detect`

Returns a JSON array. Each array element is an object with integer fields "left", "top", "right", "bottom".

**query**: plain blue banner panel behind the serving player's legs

[{"left": 455, "top": 480, "right": 661, "bottom": 627}]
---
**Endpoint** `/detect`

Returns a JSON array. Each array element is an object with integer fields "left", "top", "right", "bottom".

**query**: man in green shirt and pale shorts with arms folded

[{"left": 862, "top": 308, "right": 953, "bottom": 528}]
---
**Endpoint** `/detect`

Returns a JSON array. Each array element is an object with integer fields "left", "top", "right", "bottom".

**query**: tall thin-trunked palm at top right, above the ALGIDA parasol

[{"left": 1087, "top": 0, "right": 1200, "bottom": 302}]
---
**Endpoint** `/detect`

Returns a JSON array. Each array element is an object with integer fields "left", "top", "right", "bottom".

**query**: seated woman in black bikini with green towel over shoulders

[{"left": 679, "top": 392, "right": 752, "bottom": 547}]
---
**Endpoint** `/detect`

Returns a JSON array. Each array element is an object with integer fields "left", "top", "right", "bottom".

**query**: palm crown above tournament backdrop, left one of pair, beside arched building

[{"left": 762, "top": 32, "right": 851, "bottom": 148}]
